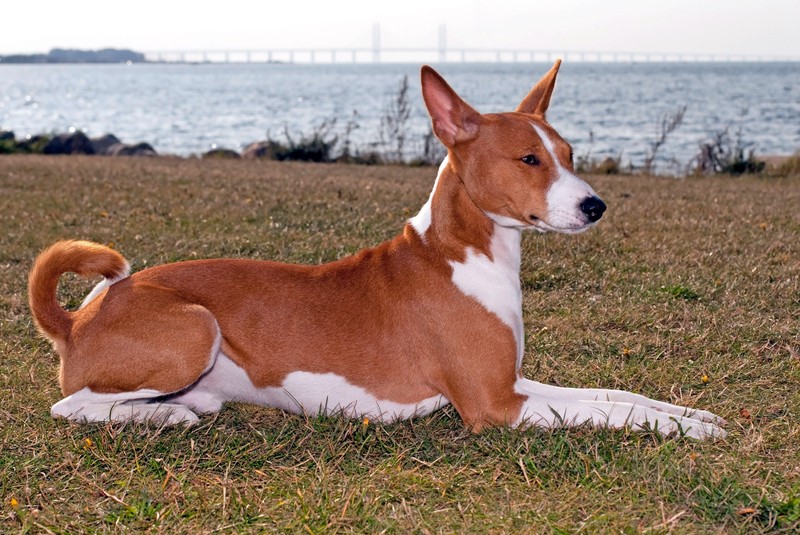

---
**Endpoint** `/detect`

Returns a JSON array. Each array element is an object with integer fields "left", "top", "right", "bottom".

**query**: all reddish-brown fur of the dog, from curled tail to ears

[{"left": 30, "top": 61, "right": 568, "bottom": 430}]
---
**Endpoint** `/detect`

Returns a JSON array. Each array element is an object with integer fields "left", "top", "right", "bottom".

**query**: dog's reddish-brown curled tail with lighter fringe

[{"left": 28, "top": 240, "right": 130, "bottom": 343}]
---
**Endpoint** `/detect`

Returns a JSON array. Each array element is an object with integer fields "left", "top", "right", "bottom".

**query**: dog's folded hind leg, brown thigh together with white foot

[{"left": 52, "top": 282, "right": 222, "bottom": 424}]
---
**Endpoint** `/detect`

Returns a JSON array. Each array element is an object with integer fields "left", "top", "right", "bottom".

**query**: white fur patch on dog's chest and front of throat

[{"left": 450, "top": 224, "right": 525, "bottom": 369}]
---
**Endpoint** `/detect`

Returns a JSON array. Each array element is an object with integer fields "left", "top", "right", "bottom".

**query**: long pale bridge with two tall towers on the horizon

[{"left": 144, "top": 24, "right": 800, "bottom": 64}]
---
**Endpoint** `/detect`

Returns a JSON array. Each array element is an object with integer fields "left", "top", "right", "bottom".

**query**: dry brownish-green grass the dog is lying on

[{"left": 0, "top": 156, "right": 800, "bottom": 533}]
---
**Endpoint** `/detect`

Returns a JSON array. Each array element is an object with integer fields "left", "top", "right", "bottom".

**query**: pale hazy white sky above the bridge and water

[{"left": 0, "top": 0, "right": 800, "bottom": 59}]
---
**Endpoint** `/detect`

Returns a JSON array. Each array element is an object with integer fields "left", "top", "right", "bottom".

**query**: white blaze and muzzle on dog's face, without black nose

[{"left": 532, "top": 124, "right": 596, "bottom": 233}]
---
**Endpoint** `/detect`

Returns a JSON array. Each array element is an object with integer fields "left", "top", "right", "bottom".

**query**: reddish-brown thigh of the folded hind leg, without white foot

[{"left": 65, "top": 278, "right": 217, "bottom": 396}]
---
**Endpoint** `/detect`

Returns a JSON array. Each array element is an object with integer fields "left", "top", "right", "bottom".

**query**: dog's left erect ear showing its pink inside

[{"left": 420, "top": 65, "right": 480, "bottom": 147}]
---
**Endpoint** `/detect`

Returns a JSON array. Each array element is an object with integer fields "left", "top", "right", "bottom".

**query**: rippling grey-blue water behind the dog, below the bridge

[{"left": 0, "top": 63, "right": 800, "bottom": 171}]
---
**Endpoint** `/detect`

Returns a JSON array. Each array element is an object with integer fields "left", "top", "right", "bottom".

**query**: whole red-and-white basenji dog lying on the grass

[{"left": 29, "top": 62, "right": 725, "bottom": 438}]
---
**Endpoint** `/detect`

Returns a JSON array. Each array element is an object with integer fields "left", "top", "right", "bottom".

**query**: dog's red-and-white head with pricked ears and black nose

[{"left": 422, "top": 61, "right": 606, "bottom": 233}]
